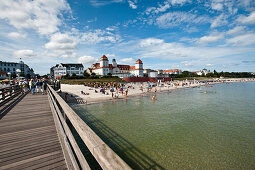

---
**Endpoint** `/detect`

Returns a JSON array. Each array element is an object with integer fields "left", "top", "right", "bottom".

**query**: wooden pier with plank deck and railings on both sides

[{"left": 0, "top": 85, "right": 131, "bottom": 170}]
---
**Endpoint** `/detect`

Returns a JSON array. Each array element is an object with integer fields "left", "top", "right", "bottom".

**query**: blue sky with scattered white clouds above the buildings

[{"left": 0, "top": 0, "right": 255, "bottom": 74}]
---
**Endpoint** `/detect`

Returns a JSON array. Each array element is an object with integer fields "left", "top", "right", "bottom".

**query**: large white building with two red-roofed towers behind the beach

[{"left": 87, "top": 55, "right": 143, "bottom": 78}]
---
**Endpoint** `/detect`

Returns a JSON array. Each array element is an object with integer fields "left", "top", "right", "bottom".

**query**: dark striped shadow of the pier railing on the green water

[{"left": 74, "top": 106, "right": 165, "bottom": 170}]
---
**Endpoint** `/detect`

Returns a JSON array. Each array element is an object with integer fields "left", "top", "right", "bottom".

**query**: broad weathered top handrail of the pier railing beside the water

[{"left": 48, "top": 85, "right": 131, "bottom": 170}]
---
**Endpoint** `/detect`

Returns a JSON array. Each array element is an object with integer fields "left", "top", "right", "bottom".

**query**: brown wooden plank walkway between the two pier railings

[{"left": 0, "top": 94, "right": 67, "bottom": 170}]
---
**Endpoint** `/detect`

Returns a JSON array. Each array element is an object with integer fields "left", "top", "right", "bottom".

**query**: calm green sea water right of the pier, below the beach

[{"left": 73, "top": 82, "right": 255, "bottom": 169}]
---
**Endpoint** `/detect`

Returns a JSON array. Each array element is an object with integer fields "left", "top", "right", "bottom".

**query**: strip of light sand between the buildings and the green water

[{"left": 60, "top": 79, "right": 255, "bottom": 105}]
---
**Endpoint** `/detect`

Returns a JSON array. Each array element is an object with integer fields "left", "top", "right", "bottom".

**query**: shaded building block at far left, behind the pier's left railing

[{"left": 0, "top": 61, "right": 35, "bottom": 79}]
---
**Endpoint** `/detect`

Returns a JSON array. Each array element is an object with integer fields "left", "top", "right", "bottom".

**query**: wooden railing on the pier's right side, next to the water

[{"left": 48, "top": 85, "right": 131, "bottom": 170}]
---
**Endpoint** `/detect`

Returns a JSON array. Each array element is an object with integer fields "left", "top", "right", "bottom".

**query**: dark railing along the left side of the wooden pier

[{"left": 0, "top": 85, "right": 21, "bottom": 106}]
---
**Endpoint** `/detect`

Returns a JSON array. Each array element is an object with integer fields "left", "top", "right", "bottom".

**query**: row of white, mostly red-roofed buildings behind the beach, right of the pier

[{"left": 50, "top": 55, "right": 210, "bottom": 78}]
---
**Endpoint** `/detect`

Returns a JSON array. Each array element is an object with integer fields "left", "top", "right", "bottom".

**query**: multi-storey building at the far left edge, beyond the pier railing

[{"left": 0, "top": 61, "right": 35, "bottom": 77}]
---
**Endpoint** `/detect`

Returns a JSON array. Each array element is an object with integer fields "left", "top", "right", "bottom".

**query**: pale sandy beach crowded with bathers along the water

[{"left": 58, "top": 79, "right": 254, "bottom": 104}]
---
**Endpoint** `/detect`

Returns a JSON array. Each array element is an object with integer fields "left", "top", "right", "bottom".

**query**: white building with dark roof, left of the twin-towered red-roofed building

[{"left": 51, "top": 63, "right": 84, "bottom": 79}]
